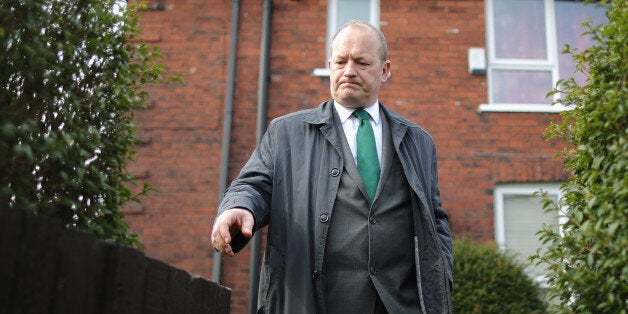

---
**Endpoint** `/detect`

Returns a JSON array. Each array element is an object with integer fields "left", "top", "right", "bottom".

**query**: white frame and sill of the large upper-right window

[{"left": 479, "top": 0, "right": 570, "bottom": 113}]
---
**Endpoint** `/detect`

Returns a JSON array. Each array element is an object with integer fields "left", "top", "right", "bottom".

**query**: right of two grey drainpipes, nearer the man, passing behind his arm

[{"left": 247, "top": 0, "right": 273, "bottom": 314}]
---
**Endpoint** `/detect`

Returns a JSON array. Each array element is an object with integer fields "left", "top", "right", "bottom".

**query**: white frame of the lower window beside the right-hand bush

[{"left": 493, "top": 183, "right": 567, "bottom": 285}]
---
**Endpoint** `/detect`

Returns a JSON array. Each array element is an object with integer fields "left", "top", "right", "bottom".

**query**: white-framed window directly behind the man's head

[{"left": 313, "top": 0, "right": 379, "bottom": 76}]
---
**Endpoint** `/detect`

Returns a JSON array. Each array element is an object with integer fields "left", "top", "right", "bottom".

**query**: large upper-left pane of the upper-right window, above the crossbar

[{"left": 493, "top": 0, "right": 547, "bottom": 60}]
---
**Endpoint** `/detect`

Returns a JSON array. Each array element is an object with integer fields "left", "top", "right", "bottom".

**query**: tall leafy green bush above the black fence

[{"left": 0, "top": 0, "right": 169, "bottom": 245}]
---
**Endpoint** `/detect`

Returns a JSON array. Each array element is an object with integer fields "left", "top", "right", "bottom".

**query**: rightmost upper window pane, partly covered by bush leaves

[{"left": 555, "top": 1, "right": 606, "bottom": 84}]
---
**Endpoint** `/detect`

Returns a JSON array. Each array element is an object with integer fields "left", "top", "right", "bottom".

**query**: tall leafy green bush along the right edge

[{"left": 534, "top": 0, "right": 628, "bottom": 313}]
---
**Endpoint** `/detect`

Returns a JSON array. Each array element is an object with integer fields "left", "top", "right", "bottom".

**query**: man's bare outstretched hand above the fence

[{"left": 212, "top": 207, "right": 254, "bottom": 256}]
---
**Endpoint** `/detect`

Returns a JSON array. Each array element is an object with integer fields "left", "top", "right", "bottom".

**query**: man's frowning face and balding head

[{"left": 328, "top": 27, "right": 390, "bottom": 108}]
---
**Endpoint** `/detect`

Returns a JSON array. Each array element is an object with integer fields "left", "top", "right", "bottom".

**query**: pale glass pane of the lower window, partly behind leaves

[{"left": 504, "top": 194, "right": 558, "bottom": 277}]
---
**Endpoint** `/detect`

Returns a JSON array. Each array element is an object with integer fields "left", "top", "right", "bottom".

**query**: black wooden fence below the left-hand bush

[{"left": 0, "top": 208, "right": 231, "bottom": 314}]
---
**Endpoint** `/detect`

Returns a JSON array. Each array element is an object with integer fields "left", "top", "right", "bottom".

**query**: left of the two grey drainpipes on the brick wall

[{"left": 212, "top": 0, "right": 240, "bottom": 283}]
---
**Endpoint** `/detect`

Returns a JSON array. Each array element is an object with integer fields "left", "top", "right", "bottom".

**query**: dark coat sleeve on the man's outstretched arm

[{"left": 218, "top": 123, "right": 274, "bottom": 252}]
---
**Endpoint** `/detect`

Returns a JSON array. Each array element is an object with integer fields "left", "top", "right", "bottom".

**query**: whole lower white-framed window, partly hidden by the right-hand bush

[{"left": 494, "top": 184, "right": 561, "bottom": 283}]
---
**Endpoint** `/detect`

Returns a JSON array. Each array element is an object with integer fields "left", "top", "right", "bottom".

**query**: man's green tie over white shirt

[{"left": 353, "top": 109, "right": 379, "bottom": 202}]
